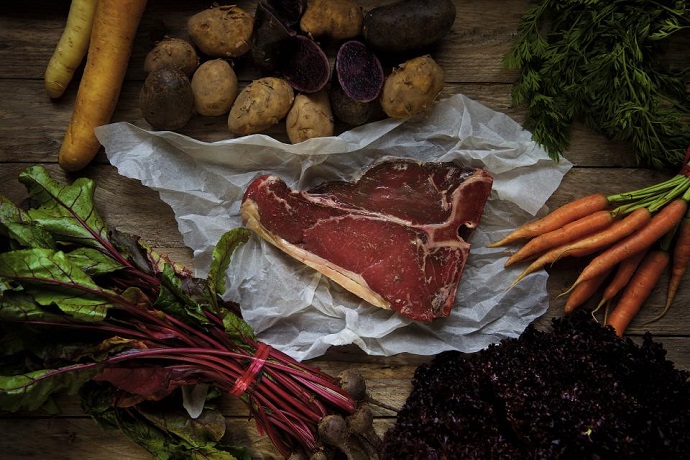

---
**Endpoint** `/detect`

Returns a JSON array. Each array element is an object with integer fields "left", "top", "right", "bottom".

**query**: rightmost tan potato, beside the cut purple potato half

[{"left": 381, "top": 55, "right": 443, "bottom": 118}]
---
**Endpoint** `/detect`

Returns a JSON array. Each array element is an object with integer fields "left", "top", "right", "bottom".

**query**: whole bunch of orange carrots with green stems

[{"left": 490, "top": 159, "right": 690, "bottom": 335}]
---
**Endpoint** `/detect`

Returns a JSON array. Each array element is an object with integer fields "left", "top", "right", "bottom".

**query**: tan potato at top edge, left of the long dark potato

[{"left": 299, "top": 0, "right": 364, "bottom": 40}]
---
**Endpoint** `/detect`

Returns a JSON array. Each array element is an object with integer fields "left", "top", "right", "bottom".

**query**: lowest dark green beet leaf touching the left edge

[{"left": 0, "top": 365, "right": 97, "bottom": 412}]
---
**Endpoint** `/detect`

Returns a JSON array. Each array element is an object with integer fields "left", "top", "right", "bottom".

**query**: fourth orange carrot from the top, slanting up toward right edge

[{"left": 573, "top": 199, "right": 688, "bottom": 286}]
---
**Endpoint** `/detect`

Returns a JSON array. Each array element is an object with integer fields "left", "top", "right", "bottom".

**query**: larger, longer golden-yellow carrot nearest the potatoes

[{"left": 58, "top": 0, "right": 146, "bottom": 171}]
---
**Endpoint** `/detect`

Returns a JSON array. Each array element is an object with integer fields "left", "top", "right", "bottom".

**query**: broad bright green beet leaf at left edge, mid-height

[{"left": 0, "top": 249, "right": 118, "bottom": 321}]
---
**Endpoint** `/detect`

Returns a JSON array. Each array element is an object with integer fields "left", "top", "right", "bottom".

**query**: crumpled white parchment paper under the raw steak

[{"left": 96, "top": 95, "right": 572, "bottom": 360}]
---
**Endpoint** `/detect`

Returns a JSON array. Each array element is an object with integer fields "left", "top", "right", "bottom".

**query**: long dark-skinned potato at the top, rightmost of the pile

[{"left": 362, "top": 0, "right": 456, "bottom": 53}]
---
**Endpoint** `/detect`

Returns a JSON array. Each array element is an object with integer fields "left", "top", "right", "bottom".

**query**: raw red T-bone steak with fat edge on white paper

[{"left": 241, "top": 159, "right": 493, "bottom": 322}]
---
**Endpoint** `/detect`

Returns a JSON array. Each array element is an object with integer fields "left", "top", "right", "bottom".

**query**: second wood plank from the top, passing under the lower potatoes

[{"left": 0, "top": 79, "right": 635, "bottom": 167}]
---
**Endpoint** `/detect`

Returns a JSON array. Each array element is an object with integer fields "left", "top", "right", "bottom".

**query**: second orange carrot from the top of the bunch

[{"left": 505, "top": 211, "right": 614, "bottom": 267}]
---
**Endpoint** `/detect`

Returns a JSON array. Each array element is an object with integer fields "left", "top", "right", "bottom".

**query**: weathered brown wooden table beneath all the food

[{"left": 0, "top": 0, "right": 690, "bottom": 460}]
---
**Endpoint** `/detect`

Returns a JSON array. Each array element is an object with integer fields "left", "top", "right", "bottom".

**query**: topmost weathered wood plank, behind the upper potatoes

[{"left": 0, "top": 0, "right": 528, "bottom": 82}]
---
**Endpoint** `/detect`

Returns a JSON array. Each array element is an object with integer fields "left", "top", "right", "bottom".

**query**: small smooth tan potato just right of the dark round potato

[{"left": 192, "top": 59, "right": 238, "bottom": 117}]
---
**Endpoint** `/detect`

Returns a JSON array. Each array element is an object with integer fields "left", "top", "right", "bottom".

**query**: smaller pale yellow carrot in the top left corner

[{"left": 43, "top": 0, "right": 97, "bottom": 99}]
